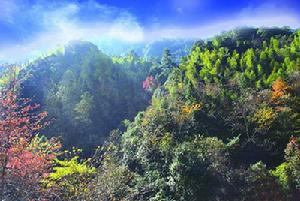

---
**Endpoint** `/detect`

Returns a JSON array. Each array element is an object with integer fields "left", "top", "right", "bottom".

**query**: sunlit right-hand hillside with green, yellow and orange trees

[{"left": 85, "top": 29, "right": 300, "bottom": 201}]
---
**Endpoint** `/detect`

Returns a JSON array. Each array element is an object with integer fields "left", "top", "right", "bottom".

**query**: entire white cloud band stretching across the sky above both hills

[{"left": 0, "top": 0, "right": 300, "bottom": 62}]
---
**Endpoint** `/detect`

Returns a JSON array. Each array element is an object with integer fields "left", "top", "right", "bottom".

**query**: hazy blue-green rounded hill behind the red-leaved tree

[{"left": 19, "top": 41, "right": 151, "bottom": 153}]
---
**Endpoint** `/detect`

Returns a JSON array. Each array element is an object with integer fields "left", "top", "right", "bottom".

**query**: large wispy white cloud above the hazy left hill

[{"left": 0, "top": 0, "right": 144, "bottom": 62}]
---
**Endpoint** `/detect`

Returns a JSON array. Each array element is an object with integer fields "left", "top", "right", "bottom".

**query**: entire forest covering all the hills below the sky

[{"left": 0, "top": 27, "right": 300, "bottom": 201}]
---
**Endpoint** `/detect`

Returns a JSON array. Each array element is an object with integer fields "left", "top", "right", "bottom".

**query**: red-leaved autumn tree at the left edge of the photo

[{"left": 0, "top": 80, "right": 60, "bottom": 200}]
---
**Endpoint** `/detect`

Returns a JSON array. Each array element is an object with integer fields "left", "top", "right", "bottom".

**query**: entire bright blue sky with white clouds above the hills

[{"left": 0, "top": 0, "right": 300, "bottom": 61}]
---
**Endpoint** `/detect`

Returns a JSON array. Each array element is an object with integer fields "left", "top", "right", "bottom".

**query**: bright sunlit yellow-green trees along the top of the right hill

[{"left": 182, "top": 29, "right": 299, "bottom": 89}]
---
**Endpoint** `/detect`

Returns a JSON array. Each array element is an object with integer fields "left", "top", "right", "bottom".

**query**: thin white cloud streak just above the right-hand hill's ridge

[{"left": 147, "top": 2, "right": 300, "bottom": 40}]
